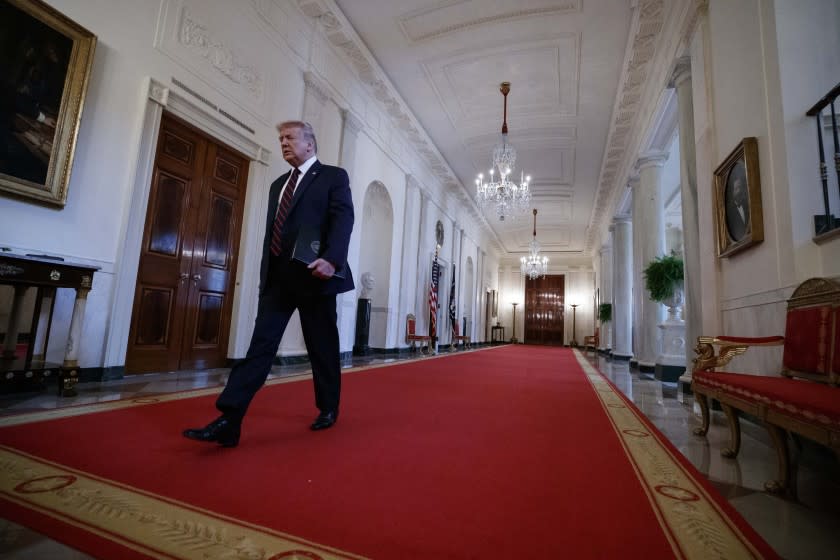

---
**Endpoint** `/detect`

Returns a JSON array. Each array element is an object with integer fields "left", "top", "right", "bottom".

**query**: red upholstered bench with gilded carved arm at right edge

[{"left": 691, "top": 278, "right": 840, "bottom": 497}]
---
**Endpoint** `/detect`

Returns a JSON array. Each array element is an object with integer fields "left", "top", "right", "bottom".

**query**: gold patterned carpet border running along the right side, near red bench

[{"left": 575, "top": 350, "right": 763, "bottom": 560}]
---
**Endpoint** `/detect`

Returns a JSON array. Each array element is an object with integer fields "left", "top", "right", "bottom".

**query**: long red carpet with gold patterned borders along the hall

[{"left": 0, "top": 345, "right": 776, "bottom": 559}]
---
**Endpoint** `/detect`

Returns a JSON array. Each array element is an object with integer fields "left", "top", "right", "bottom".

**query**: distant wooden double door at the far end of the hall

[{"left": 524, "top": 275, "right": 566, "bottom": 346}]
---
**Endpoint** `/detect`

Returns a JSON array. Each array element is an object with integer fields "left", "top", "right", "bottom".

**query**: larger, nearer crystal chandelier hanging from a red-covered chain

[{"left": 475, "top": 82, "right": 531, "bottom": 221}]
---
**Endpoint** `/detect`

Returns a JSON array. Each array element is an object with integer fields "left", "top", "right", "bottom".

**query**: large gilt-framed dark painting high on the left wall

[{"left": 0, "top": 0, "right": 96, "bottom": 206}]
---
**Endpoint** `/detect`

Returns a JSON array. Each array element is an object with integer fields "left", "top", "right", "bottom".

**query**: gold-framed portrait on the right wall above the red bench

[{"left": 714, "top": 137, "right": 764, "bottom": 257}]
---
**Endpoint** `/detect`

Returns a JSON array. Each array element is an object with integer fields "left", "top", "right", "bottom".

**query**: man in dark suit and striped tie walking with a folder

[{"left": 184, "top": 121, "right": 354, "bottom": 447}]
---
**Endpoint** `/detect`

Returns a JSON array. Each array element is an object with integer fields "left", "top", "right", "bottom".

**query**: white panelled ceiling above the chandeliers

[{"left": 332, "top": 0, "right": 632, "bottom": 255}]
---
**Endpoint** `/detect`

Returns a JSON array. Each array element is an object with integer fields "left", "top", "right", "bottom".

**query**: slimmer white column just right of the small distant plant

[{"left": 611, "top": 216, "right": 633, "bottom": 360}]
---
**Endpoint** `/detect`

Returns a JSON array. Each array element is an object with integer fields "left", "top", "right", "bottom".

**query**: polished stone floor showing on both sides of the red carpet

[{"left": 0, "top": 352, "right": 840, "bottom": 560}]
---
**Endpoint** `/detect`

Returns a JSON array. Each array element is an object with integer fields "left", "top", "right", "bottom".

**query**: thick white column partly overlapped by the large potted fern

[{"left": 633, "top": 152, "right": 668, "bottom": 373}]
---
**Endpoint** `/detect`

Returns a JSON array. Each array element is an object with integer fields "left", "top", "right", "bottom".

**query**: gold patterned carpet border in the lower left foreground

[{"left": 0, "top": 446, "right": 362, "bottom": 560}]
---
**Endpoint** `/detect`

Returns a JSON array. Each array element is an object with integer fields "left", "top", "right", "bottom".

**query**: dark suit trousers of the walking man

[{"left": 216, "top": 272, "right": 341, "bottom": 421}]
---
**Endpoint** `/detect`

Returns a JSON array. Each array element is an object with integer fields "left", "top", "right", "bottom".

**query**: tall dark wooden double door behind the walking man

[{"left": 126, "top": 113, "right": 249, "bottom": 373}]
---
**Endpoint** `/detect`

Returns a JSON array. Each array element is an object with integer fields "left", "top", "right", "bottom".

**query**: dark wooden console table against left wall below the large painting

[{"left": 0, "top": 253, "right": 99, "bottom": 397}]
